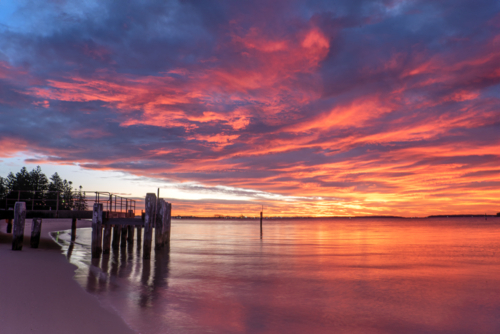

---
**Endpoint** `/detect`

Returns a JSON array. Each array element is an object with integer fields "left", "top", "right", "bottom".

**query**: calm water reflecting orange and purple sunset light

[{"left": 51, "top": 217, "right": 500, "bottom": 334}]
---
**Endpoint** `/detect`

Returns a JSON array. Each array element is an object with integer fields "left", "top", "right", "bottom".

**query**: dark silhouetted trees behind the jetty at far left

[{"left": 0, "top": 166, "right": 87, "bottom": 210}]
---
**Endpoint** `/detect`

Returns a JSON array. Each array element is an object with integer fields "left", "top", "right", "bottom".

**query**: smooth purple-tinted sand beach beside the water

[{"left": 0, "top": 219, "right": 135, "bottom": 334}]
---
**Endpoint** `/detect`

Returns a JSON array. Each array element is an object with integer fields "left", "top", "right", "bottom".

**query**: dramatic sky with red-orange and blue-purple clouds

[{"left": 0, "top": 0, "right": 500, "bottom": 217}]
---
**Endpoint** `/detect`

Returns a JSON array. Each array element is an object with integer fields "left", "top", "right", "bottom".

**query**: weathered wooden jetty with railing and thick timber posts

[{"left": 0, "top": 192, "right": 172, "bottom": 259}]
